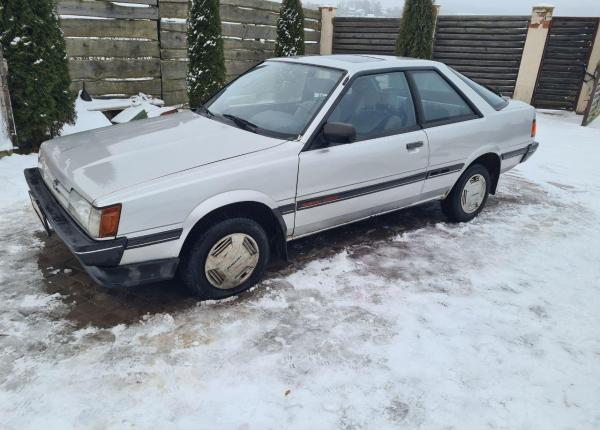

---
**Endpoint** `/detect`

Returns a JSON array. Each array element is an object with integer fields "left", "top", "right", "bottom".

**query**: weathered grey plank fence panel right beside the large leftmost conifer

[{"left": 57, "top": 0, "right": 161, "bottom": 97}]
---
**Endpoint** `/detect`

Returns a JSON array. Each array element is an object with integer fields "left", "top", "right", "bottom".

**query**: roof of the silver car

[{"left": 268, "top": 54, "right": 440, "bottom": 73}]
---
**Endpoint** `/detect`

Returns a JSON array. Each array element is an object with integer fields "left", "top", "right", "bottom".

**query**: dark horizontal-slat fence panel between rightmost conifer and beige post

[{"left": 433, "top": 15, "right": 530, "bottom": 96}]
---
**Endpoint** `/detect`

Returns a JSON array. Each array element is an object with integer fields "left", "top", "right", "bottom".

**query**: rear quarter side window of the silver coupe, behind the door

[{"left": 411, "top": 70, "right": 475, "bottom": 122}]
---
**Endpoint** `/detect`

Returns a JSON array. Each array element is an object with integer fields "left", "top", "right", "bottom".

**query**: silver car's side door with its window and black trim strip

[{"left": 294, "top": 72, "right": 429, "bottom": 236}]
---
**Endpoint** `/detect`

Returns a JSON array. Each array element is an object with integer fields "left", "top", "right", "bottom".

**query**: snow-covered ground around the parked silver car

[{"left": 0, "top": 113, "right": 600, "bottom": 430}]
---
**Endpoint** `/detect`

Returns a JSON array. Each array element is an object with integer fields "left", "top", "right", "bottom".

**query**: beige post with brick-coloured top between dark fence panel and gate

[{"left": 513, "top": 6, "right": 554, "bottom": 103}]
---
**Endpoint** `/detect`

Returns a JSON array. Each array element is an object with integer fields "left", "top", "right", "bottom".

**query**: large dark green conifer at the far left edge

[{"left": 0, "top": 0, "right": 75, "bottom": 150}]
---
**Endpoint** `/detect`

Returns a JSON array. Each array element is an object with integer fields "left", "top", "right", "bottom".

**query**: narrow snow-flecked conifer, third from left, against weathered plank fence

[{"left": 275, "top": 0, "right": 304, "bottom": 57}]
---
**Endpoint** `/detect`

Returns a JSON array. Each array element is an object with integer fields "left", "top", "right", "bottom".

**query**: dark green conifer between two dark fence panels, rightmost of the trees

[{"left": 396, "top": 0, "right": 435, "bottom": 59}]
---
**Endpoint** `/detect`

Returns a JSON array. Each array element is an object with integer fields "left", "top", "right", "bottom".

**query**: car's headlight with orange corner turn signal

[{"left": 69, "top": 190, "right": 121, "bottom": 238}]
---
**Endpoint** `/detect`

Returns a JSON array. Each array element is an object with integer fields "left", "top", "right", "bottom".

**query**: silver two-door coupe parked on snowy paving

[{"left": 25, "top": 55, "right": 538, "bottom": 299}]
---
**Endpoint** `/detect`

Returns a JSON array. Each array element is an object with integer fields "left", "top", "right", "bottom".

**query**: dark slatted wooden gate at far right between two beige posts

[{"left": 532, "top": 17, "right": 598, "bottom": 110}]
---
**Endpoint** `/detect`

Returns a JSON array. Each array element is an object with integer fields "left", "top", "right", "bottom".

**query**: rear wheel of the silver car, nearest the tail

[{"left": 442, "top": 164, "right": 491, "bottom": 222}]
